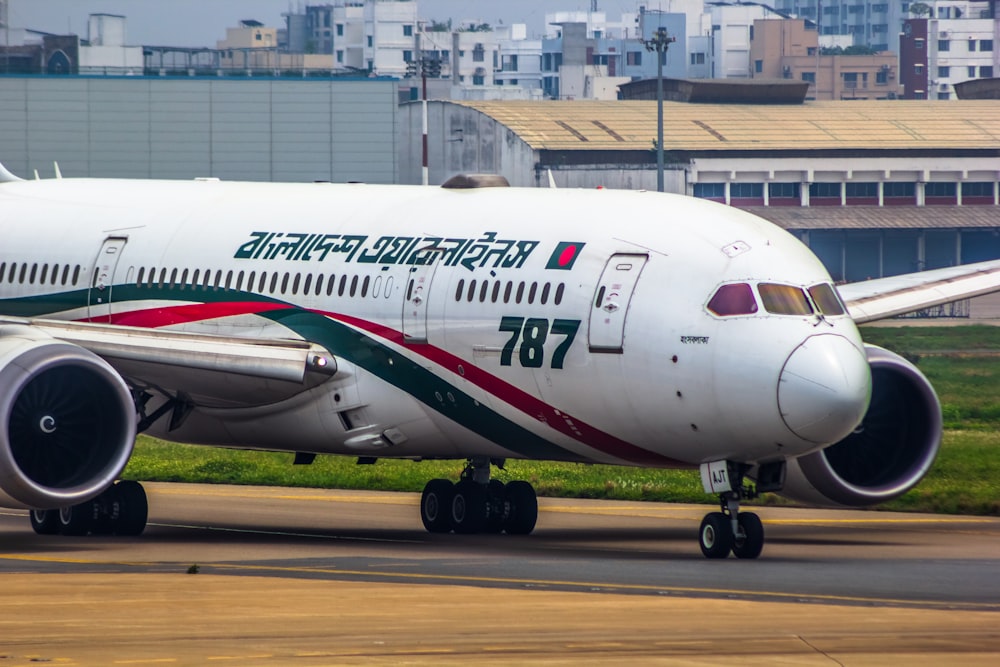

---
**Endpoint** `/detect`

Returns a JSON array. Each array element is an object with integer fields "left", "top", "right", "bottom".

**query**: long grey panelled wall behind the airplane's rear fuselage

[{"left": 0, "top": 77, "right": 397, "bottom": 183}]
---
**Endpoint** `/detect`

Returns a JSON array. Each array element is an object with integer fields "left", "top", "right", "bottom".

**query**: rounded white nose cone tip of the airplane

[{"left": 778, "top": 334, "right": 871, "bottom": 444}]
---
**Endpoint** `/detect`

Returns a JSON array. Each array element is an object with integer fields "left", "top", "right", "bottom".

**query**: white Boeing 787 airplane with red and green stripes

[{"left": 0, "top": 167, "right": 1000, "bottom": 559}]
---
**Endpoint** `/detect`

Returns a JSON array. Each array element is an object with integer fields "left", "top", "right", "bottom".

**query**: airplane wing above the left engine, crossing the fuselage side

[{"left": 0, "top": 318, "right": 338, "bottom": 407}]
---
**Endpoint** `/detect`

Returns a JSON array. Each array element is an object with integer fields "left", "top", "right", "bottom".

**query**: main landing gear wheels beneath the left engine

[{"left": 30, "top": 480, "right": 149, "bottom": 536}]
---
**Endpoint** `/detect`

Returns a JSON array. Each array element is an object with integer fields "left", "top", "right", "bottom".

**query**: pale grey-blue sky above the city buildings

[{"left": 8, "top": 0, "right": 656, "bottom": 47}]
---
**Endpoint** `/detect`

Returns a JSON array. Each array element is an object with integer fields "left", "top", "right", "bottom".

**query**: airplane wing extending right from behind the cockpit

[{"left": 837, "top": 260, "right": 1000, "bottom": 324}]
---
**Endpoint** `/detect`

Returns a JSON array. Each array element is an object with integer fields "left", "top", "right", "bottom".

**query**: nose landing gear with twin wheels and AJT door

[{"left": 698, "top": 461, "right": 764, "bottom": 558}]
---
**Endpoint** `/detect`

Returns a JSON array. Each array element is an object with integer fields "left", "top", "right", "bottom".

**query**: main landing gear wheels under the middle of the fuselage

[{"left": 420, "top": 457, "right": 538, "bottom": 535}]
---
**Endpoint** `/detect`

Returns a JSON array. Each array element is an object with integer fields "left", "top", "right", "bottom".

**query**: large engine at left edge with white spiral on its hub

[{"left": 0, "top": 324, "right": 136, "bottom": 509}]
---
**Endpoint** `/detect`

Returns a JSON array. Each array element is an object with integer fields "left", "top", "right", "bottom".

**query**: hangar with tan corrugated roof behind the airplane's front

[{"left": 400, "top": 100, "right": 1000, "bottom": 292}]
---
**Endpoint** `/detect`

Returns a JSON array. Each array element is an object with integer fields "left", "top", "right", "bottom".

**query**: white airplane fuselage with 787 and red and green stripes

[{"left": 0, "top": 180, "right": 870, "bottom": 467}]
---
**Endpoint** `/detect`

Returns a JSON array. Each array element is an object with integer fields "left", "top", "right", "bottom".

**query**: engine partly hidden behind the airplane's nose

[{"left": 780, "top": 345, "right": 941, "bottom": 507}]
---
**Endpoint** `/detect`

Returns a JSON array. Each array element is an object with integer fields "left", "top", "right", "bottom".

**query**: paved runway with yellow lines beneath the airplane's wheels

[{"left": 0, "top": 484, "right": 1000, "bottom": 666}]
